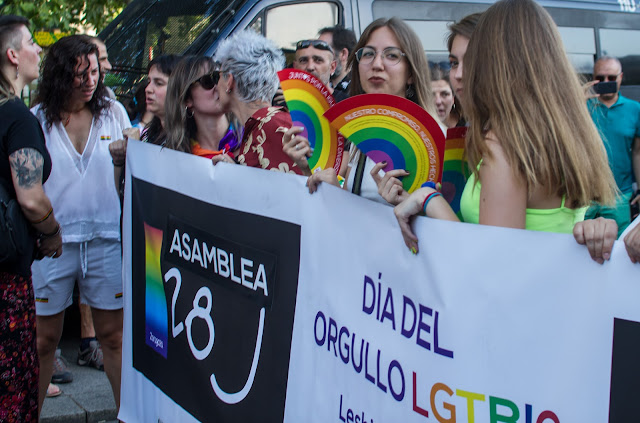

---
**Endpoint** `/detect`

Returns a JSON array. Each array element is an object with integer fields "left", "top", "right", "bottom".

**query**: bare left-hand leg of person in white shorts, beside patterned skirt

[{"left": 36, "top": 311, "right": 64, "bottom": 415}]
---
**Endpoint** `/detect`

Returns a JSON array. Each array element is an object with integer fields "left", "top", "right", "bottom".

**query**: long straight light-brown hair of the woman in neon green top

[{"left": 463, "top": 0, "right": 616, "bottom": 207}]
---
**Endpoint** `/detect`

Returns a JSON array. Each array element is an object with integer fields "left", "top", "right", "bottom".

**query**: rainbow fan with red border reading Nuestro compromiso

[{"left": 324, "top": 94, "right": 445, "bottom": 193}]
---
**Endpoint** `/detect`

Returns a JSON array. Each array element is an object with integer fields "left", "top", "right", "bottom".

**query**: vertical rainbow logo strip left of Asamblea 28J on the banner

[{"left": 144, "top": 223, "right": 169, "bottom": 358}]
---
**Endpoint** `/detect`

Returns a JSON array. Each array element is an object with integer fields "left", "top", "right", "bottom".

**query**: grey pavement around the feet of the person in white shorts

[{"left": 40, "top": 305, "right": 117, "bottom": 423}]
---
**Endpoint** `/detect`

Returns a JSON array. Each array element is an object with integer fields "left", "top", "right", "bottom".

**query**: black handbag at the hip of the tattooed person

[{"left": 0, "top": 183, "right": 34, "bottom": 264}]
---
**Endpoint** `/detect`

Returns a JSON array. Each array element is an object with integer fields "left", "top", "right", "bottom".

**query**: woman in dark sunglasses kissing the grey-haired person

[{"left": 165, "top": 56, "right": 238, "bottom": 159}]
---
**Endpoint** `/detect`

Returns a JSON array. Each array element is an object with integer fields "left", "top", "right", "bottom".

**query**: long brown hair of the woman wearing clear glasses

[{"left": 347, "top": 17, "right": 437, "bottom": 116}]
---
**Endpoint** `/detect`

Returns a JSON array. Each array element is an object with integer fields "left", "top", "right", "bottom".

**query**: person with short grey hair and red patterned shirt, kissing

[{"left": 213, "top": 30, "right": 302, "bottom": 175}]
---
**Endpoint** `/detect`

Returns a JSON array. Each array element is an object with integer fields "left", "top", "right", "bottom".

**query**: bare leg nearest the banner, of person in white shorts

[{"left": 91, "top": 308, "right": 123, "bottom": 410}]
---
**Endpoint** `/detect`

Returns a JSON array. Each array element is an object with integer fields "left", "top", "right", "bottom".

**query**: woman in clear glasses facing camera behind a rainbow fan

[{"left": 284, "top": 17, "right": 438, "bottom": 205}]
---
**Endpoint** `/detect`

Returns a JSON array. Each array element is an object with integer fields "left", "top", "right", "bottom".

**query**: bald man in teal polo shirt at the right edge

[{"left": 585, "top": 56, "right": 640, "bottom": 235}]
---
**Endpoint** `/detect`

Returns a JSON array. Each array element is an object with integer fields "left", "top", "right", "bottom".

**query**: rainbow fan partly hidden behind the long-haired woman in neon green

[{"left": 442, "top": 127, "right": 469, "bottom": 219}]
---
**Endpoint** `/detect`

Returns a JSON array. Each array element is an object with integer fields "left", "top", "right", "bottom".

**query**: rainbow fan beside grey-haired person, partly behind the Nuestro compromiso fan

[{"left": 278, "top": 69, "right": 344, "bottom": 173}]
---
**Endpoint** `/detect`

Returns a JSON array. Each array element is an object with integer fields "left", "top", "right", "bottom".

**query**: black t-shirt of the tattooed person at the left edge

[{"left": 0, "top": 98, "right": 51, "bottom": 276}]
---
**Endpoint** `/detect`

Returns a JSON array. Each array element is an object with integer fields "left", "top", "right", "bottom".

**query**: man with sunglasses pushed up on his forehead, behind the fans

[{"left": 293, "top": 40, "right": 336, "bottom": 94}]
